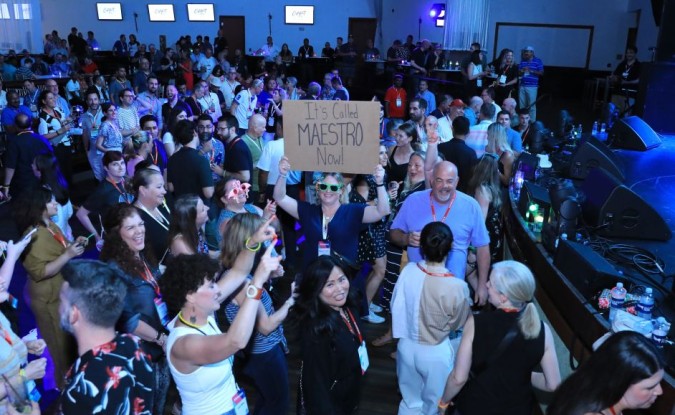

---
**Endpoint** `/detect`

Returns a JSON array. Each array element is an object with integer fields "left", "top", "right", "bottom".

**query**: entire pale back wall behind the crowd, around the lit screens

[{"left": 34, "top": 0, "right": 658, "bottom": 70}]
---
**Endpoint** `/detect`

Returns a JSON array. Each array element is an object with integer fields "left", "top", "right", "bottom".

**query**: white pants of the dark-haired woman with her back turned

[{"left": 396, "top": 339, "right": 455, "bottom": 415}]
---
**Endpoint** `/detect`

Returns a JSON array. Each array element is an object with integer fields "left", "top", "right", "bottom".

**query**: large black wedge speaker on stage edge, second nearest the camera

[{"left": 581, "top": 169, "right": 671, "bottom": 241}]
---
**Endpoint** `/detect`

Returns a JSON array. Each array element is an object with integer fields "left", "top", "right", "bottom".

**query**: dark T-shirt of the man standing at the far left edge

[{"left": 5, "top": 133, "right": 52, "bottom": 197}]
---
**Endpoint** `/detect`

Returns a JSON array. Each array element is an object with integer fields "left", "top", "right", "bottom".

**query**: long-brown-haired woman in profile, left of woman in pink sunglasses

[{"left": 169, "top": 194, "right": 211, "bottom": 256}]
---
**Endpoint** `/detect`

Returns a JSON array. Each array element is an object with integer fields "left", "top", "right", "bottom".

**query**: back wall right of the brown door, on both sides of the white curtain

[{"left": 383, "top": 0, "right": 658, "bottom": 70}]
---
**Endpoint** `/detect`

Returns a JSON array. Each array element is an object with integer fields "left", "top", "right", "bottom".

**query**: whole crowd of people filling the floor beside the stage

[{"left": 0, "top": 28, "right": 663, "bottom": 415}]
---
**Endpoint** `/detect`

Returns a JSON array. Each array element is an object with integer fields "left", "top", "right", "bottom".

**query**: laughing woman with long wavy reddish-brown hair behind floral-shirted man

[{"left": 101, "top": 204, "right": 169, "bottom": 413}]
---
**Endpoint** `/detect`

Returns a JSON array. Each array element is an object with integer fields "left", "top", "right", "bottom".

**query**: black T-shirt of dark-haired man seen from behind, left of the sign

[{"left": 167, "top": 147, "right": 213, "bottom": 198}]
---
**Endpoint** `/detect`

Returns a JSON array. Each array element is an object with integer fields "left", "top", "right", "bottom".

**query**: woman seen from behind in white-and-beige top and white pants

[{"left": 391, "top": 222, "right": 471, "bottom": 415}]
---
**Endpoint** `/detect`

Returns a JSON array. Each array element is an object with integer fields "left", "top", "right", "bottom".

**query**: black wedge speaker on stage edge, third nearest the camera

[{"left": 569, "top": 137, "right": 626, "bottom": 181}]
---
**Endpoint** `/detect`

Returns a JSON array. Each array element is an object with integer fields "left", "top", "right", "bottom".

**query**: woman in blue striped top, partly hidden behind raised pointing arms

[{"left": 220, "top": 213, "right": 294, "bottom": 415}]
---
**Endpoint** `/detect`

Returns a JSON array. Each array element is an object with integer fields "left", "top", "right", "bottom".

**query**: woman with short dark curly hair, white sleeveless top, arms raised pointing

[{"left": 159, "top": 220, "right": 280, "bottom": 415}]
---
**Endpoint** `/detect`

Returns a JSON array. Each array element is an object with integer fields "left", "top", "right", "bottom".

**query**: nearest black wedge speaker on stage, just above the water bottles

[{"left": 553, "top": 240, "right": 626, "bottom": 300}]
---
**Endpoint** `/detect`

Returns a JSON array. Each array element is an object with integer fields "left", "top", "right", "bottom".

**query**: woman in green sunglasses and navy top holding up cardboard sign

[{"left": 274, "top": 157, "right": 389, "bottom": 269}]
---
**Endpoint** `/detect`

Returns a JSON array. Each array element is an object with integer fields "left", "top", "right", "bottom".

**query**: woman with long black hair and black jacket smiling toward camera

[{"left": 291, "top": 255, "right": 367, "bottom": 415}]
